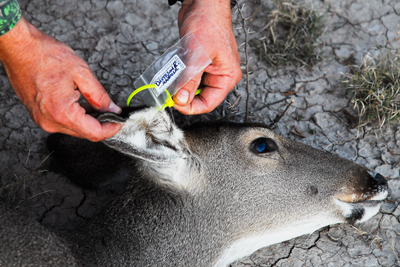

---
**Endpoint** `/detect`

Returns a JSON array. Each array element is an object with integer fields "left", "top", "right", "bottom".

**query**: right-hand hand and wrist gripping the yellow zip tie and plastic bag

[{"left": 174, "top": 0, "right": 242, "bottom": 114}]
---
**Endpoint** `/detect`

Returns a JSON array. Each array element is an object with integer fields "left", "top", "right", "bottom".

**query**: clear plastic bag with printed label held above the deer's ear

[{"left": 134, "top": 32, "right": 212, "bottom": 109}]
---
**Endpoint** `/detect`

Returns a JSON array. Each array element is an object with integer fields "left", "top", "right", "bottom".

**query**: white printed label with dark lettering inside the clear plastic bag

[{"left": 150, "top": 55, "right": 186, "bottom": 97}]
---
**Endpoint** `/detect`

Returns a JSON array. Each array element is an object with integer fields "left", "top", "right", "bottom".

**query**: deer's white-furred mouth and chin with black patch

[{"left": 334, "top": 189, "right": 388, "bottom": 224}]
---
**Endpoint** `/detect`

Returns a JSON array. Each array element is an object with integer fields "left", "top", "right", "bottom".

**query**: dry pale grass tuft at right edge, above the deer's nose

[{"left": 343, "top": 52, "right": 400, "bottom": 129}]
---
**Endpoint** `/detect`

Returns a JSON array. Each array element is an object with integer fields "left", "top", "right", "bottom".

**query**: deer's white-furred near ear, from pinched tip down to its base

[{"left": 99, "top": 108, "right": 203, "bottom": 192}]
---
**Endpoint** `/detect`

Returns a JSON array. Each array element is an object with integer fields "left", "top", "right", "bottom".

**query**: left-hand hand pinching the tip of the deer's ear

[{"left": 0, "top": 18, "right": 122, "bottom": 141}]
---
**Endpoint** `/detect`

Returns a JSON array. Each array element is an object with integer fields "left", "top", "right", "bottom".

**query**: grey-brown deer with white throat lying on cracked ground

[{"left": 0, "top": 108, "right": 388, "bottom": 267}]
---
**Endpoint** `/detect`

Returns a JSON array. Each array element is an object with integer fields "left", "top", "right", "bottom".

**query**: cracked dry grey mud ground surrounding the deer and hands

[{"left": 0, "top": 0, "right": 400, "bottom": 267}]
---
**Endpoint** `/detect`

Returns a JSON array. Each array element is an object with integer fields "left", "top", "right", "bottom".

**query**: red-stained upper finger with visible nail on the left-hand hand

[{"left": 74, "top": 67, "right": 122, "bottom": 114}]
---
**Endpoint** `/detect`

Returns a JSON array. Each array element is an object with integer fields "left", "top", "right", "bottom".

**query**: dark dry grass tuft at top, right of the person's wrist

[{"left": 250, "top": 0, "right": 323, "bottom": 66}]
